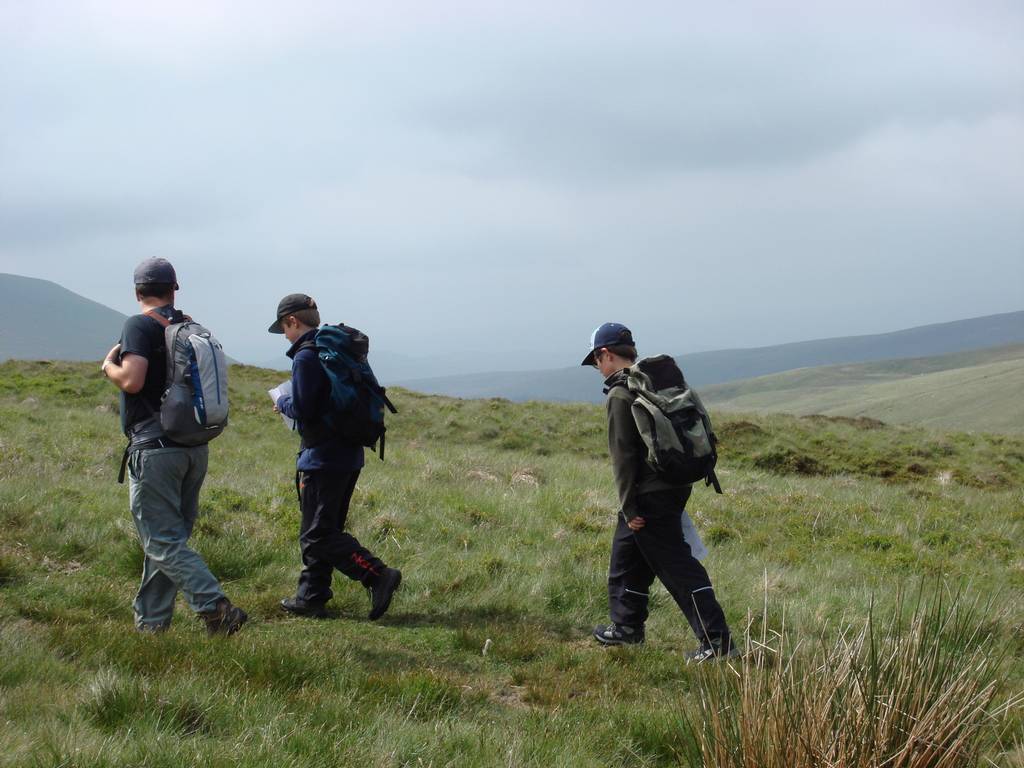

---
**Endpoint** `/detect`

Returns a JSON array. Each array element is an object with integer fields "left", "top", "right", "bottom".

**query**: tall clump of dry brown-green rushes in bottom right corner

[{"left": 686, "top": 590, "right": 1024, "bottom": 768}]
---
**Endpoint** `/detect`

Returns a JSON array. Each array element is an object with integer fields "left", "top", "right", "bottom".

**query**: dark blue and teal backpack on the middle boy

[{"left": 299, "top": 323, "right": 398, "bottom": 461}]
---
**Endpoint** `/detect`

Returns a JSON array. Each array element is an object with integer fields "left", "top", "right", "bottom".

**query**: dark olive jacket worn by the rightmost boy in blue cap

[{"left": 604, "top": 371, "right": 687, "bottom": 520}]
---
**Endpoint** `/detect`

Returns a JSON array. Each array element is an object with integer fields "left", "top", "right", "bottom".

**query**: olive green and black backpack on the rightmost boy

[{"left": 612, "top": 354, "right": 722, "bottom": 494}]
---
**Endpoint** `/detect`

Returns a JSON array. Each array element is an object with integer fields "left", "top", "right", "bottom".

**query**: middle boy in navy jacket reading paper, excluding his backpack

[{"left": 268, "top": 293, "right": 401, "bottom": 621}]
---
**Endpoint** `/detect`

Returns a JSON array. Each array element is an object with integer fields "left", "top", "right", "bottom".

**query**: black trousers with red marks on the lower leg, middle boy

[{"left": 295, "top": 470, "right": 385, "bottom": 603}]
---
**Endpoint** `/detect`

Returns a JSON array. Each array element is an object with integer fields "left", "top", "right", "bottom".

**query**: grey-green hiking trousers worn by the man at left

[{"left": 128, "top": 445, "right": 224, "bottom": 630}]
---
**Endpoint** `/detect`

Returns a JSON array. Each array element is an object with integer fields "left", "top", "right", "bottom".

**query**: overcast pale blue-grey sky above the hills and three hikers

[{"left": 0, "top": 0, "right": 1024, "bottom": 374}]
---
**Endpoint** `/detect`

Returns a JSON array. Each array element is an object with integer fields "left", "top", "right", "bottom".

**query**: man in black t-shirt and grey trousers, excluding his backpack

[{"left": 100, "top": 259, "right": 248, "bottom": 635}]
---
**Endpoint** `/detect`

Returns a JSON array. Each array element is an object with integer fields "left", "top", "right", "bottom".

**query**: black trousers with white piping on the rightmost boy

[{"left": 608, "top": 488, "right": 729, "bottom": 642}]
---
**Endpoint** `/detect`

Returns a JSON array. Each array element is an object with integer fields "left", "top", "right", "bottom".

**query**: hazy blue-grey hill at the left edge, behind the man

[{"left": 0, "top": 273, "right": 125, "bottom": 360}]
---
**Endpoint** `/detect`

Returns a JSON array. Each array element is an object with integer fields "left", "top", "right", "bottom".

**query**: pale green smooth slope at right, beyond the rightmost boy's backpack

[{"left": 701, "top": 345, "right": 1024, "bottom": 433}]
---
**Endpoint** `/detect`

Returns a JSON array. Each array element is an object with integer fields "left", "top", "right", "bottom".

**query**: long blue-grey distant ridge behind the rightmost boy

[{"left": 399, "top": 311, "right": 1024, "bottom": 402}]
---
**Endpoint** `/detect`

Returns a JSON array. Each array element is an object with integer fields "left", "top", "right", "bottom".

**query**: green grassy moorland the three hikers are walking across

[{"left": 0, "top": 362, "right": 1024, "bottom": 768}]
